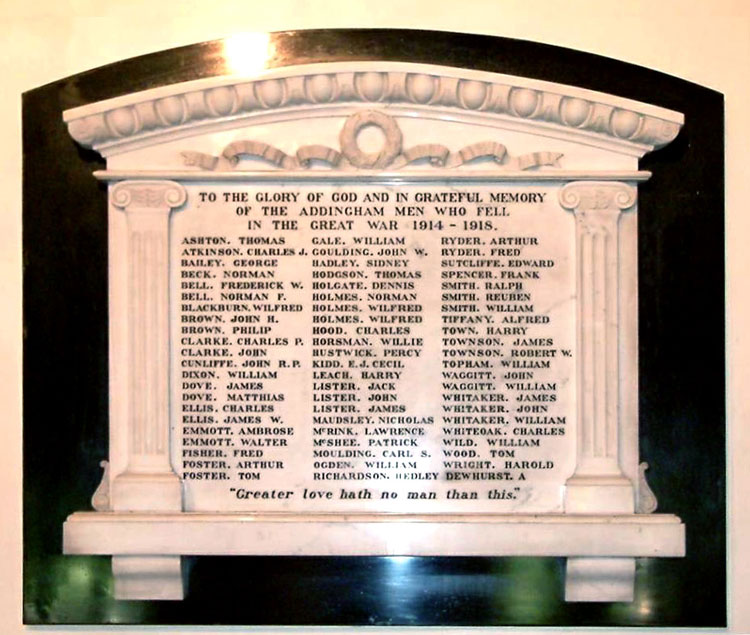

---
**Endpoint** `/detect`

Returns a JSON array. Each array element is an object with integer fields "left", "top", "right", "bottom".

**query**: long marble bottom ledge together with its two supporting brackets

[{"left": 63, "top": 512, "right": 685, "bottom": 602}]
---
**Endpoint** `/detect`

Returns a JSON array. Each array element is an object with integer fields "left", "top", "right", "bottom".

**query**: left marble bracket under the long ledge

[{"left": 112, "top": 556, "right": 185, "bottom": 600}]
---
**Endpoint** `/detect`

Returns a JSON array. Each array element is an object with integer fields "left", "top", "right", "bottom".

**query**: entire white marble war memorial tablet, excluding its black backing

[{"left": 65, "top": 57, "right": 684, "bottom": 601}]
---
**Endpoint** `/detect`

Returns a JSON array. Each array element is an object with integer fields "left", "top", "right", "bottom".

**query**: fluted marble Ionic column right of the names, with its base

[{"left": 560, "top": 181, "right": 637, "bottom": 514}]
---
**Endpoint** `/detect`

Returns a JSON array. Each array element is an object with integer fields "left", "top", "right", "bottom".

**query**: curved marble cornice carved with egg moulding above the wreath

[{"left": 64, "top": 62, "right": 683, "bottom": 154}]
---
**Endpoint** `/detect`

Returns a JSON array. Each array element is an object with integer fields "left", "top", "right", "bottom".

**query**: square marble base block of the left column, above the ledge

[{"left": 111, "top": 472, "right": 182, "bottom": 512}]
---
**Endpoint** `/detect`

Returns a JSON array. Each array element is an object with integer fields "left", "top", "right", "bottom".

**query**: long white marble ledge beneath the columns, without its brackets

[{"left": 63, "top": 512, "right": 685, "bottom": 557}]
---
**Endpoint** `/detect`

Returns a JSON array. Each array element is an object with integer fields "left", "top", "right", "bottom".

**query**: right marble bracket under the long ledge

[{"left": 565, "top": 558, "right": 635, "bottom": 602}]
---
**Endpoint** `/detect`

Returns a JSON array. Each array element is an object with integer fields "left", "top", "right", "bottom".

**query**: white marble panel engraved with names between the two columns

[{"left": 171, "top": 184, "right": 576, "bottom": 512}]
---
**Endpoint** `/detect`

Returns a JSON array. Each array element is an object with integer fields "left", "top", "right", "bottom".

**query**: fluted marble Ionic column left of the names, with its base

[{"left": 110, "top": 181, "right": 186, "bottom": 511}]
